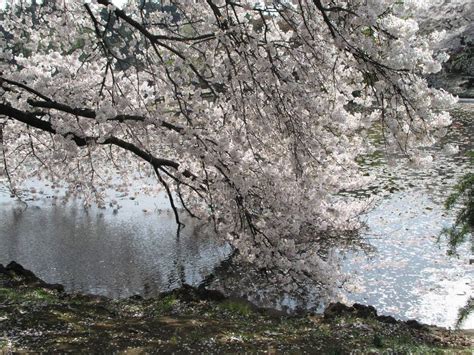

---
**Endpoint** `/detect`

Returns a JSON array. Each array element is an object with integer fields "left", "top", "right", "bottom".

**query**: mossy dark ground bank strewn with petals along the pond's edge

[{"left": 0, "top": 268, "right": 474, "bottom": 354}]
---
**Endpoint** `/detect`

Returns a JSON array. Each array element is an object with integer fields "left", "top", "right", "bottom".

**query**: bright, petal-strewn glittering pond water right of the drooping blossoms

[{"left": 344, "top": 104, "right": 474, "bottom": 328}]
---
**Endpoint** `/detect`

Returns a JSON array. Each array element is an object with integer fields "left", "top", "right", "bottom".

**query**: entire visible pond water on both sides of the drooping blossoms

[{"left": 0, "top": 103, "right": 474, "bottom": 328}]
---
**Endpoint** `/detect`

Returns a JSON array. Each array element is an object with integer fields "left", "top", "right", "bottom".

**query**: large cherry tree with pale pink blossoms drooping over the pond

[{"left": 0, "top": 0, "right": 460, "bottom": 292}]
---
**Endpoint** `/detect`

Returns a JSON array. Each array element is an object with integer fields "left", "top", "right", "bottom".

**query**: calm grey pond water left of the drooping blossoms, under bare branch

[{"left": 0, "top": 203, "right": 228, "bottom": 297}]
